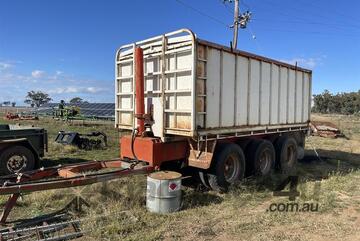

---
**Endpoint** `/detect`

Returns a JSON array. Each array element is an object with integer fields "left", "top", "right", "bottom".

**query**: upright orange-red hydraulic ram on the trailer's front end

[{"left": 135, "top": 47, "right": 145, "bottom": 135}]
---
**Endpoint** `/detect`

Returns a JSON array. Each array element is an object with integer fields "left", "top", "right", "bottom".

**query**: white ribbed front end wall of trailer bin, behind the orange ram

[{"left": 115, "top": 29, "right": 196, "bottom": 137}]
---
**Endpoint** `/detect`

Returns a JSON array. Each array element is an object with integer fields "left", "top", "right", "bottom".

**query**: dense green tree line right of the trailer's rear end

[{"left": 312, "top": 90, "right": 360, "bottom": 115}]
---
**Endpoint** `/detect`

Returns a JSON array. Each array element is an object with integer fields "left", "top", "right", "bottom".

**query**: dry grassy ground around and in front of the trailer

[{"left": 1, "top": 116, "right": 360, "bottom": 241}]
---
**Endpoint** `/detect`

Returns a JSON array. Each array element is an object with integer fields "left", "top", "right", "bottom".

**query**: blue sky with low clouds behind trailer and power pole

[{"left": 0, "top": 0, "right": 360, "bottom": 105}]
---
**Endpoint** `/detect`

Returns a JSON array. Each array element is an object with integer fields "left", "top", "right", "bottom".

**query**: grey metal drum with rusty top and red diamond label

[{"left": 146, "top": 171, "right": 181, "bottom": 213}]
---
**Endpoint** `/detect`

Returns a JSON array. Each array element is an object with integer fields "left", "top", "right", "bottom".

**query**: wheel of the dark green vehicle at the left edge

[{"left": 0, "top": 146, "right": 35, "bottom": 175}]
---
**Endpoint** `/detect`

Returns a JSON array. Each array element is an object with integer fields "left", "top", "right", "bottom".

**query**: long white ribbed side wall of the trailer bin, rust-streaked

[{"left": 202, "top": 41, "right": 311, "bottom": 133}]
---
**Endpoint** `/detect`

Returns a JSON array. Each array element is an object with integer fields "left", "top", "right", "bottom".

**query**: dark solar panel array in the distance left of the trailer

[{"left": 38, "top": 103, "right": 115, "bottom": 118}]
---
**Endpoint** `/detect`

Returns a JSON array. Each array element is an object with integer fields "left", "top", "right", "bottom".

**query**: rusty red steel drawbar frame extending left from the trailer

[{"left": 0, "top": 159, "right": 154, "bottom": 224}]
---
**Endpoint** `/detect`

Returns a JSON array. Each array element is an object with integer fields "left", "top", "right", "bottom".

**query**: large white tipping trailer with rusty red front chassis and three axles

[{"left": 115, "top": 29, "right": 312, "bottom": 191}]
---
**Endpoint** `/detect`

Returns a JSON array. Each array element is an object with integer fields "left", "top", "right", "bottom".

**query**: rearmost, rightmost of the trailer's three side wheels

[{"left": 275, "top": 136, "right": 298, "bottom": 174}]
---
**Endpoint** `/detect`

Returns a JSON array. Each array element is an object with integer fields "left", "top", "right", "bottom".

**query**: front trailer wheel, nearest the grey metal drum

[{"left": 207, "top": 143, "right": 245, "bottom": 192}]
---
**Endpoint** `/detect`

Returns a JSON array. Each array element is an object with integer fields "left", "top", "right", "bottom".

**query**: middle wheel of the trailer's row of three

[{"left": 246, "top": 140, "right": 275, "bottom": 176}]
